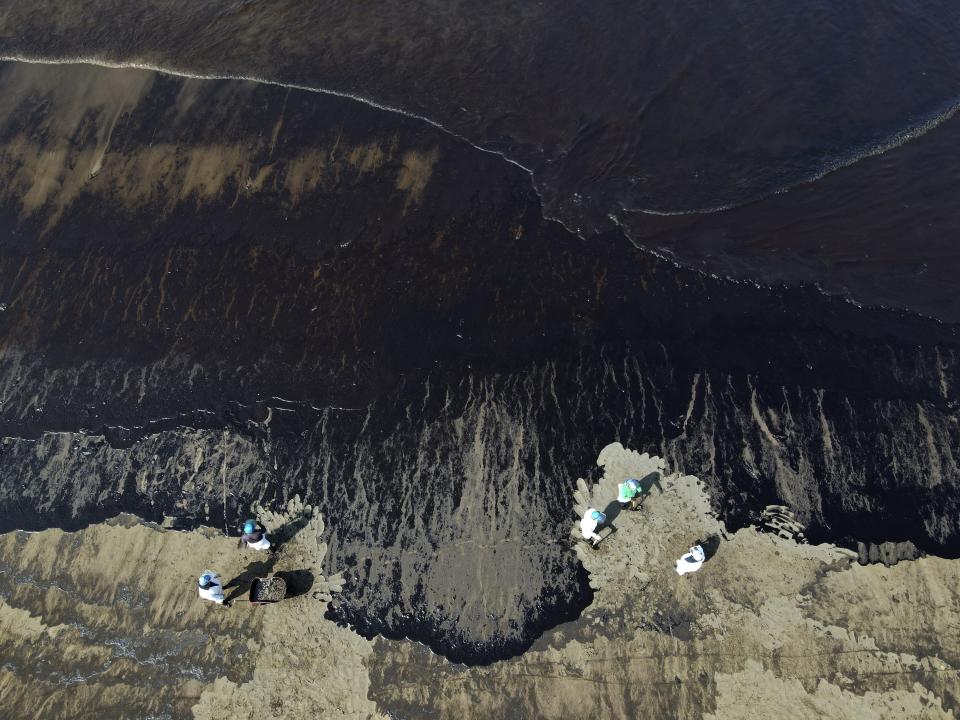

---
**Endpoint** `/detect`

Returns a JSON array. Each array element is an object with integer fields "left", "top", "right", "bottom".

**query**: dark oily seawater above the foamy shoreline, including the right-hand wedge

[{"left": 0, "top": 0, "right": 960, "bottom": 322}]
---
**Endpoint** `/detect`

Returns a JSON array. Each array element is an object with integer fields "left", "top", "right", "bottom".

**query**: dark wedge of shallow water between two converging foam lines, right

[{"left": 621, "top": 112, "right": 960, "bottom": 322}]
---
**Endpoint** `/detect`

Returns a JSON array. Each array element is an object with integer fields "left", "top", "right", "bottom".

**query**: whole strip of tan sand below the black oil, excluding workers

[{"left": 0, "top": 443, "right": 960, "bottom": 719}]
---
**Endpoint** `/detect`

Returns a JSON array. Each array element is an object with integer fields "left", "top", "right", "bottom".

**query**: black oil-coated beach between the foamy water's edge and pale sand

[{"left": 0, "top": 63, "right": 960, "bottom": 663}]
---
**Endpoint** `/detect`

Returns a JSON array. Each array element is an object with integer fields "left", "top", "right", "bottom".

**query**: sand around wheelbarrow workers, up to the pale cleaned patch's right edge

[{"left": 0, "top": 499, "right": 375, "bottom": 718}]
